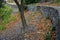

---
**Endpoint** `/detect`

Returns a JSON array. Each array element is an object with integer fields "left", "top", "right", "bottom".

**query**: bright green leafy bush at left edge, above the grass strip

[{"left": 0, "top": 5, "right": 12, "bottom": 23}]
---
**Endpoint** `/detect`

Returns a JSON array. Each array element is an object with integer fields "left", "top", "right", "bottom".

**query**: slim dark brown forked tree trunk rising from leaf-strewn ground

[{"left": 14, "top": 0, "right": 27, "bottom": 29}]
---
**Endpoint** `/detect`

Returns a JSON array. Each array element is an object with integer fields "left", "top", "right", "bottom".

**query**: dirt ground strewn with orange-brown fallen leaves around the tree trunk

[{"left": 0, "top": 12, "right": 51, "bottom": 40}]
